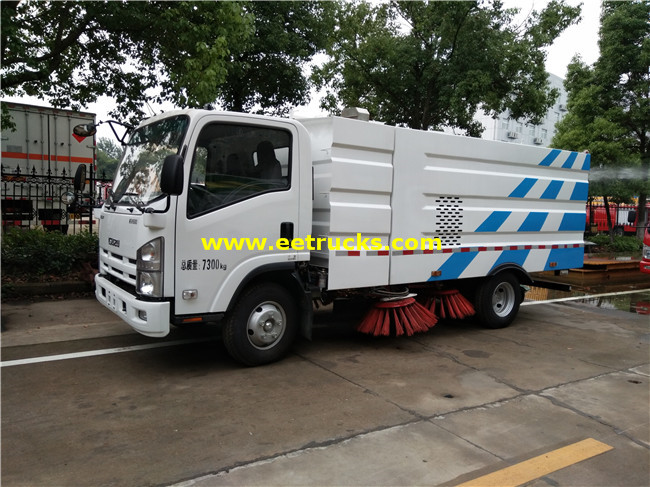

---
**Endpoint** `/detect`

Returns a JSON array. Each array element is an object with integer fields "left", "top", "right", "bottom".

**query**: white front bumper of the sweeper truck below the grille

[{"left": 95, "top": 274, "right": 171, "bottom": 337}]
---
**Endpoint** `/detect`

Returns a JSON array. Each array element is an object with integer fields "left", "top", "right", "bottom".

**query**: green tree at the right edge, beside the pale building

[{"left": 553, "top": 1, "right": 650, "bottom": 236}]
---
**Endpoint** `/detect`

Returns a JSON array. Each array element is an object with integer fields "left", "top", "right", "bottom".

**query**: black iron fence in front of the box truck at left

[{"left": 0, "top": 165, "right": 111, "bottom": 233}]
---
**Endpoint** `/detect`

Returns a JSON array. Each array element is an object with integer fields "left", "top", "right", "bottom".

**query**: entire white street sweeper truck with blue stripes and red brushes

[{"left": 83, "top": 110, "right": 590, "bottom": 365}]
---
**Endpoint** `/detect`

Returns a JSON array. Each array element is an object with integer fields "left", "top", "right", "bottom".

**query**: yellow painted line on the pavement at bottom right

[{"left": 457, "top": 438, "right": 613, "bottom": 487}]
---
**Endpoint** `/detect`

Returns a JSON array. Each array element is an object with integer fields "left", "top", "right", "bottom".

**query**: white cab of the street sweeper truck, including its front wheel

[{"left": 96, "top": 110, "right": 312, "bottom": 362}]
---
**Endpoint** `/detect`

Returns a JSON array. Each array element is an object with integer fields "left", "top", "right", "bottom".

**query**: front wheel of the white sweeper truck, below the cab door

[{"left": 223, "top": 282, "right": 298, "bottom": 366}]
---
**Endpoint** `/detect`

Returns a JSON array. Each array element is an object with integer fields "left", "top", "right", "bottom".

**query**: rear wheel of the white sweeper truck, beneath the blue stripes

[{"left": 476, "top": 272, "right": 523, "bottom": 329}]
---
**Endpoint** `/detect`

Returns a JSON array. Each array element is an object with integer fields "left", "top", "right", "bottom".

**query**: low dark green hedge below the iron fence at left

[{"left": 2, "top": 229, "right": 99, "bottom": 279}]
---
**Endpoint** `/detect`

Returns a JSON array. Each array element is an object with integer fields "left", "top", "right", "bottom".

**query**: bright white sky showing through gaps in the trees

[{"left": 7, "top": 0, "right": 600, "bottom": 143}]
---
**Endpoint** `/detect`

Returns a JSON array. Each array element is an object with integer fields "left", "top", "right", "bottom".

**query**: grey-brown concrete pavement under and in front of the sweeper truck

[{"left": 2, "top": 300, "right": 650, "bottom": 486}]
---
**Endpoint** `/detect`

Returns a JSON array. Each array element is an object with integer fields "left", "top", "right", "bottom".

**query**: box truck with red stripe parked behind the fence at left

[{"left": 1, "top": 103, "right": 95, "bottom": 233}]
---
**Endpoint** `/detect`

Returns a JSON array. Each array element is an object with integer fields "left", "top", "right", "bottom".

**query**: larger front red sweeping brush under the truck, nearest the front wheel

[{"left": 357, "top": 296, "right": 438, "bottom": 336}]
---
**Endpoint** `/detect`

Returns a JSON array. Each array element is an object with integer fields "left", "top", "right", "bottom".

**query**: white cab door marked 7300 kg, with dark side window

[{"left": 174, "top": 115, "right": 308, "bottom": 315}]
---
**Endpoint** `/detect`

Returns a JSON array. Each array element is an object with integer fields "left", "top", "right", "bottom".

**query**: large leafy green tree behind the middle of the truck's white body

[{"left": 314, "top": 1, "right": 579, "bottom": 136}]
